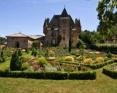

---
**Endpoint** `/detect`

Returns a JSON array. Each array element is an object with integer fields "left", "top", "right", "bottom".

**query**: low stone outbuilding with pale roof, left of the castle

[{"left": 7, "top": 33, "right": 41, "bottom": 49}]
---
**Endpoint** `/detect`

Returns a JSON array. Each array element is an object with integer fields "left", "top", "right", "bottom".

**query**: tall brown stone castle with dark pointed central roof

[{"left": 43, "top": 8, "right": 81, "bottom": 48}]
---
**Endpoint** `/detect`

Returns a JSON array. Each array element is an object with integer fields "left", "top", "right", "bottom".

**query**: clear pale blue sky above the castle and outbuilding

[{"left": 0, "top": 0, "right": 99, "bottom": 36}]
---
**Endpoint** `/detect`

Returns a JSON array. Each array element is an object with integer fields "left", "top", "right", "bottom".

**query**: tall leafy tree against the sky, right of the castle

[{"left": 97, "top": 0, "right": 117, "bottom": 35}]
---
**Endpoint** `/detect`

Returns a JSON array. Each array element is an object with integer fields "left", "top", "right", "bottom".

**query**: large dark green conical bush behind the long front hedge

[{"left": 10, "top": 51, "right": 22, "bottom": 71}]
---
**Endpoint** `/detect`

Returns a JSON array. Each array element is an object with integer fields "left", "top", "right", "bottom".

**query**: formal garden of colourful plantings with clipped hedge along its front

[{"left": 0, "top": 47, "right": 116, "bottom": 80}]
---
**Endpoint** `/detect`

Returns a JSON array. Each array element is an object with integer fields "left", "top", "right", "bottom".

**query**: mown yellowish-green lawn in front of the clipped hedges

[{"left": 0, "top": 69, "right": 117, "bottom": 93}]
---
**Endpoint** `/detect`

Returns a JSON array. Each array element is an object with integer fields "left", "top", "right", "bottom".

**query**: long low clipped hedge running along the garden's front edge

[{"left": 0, "top": 71, "right": 96, "bottom": 80}]
